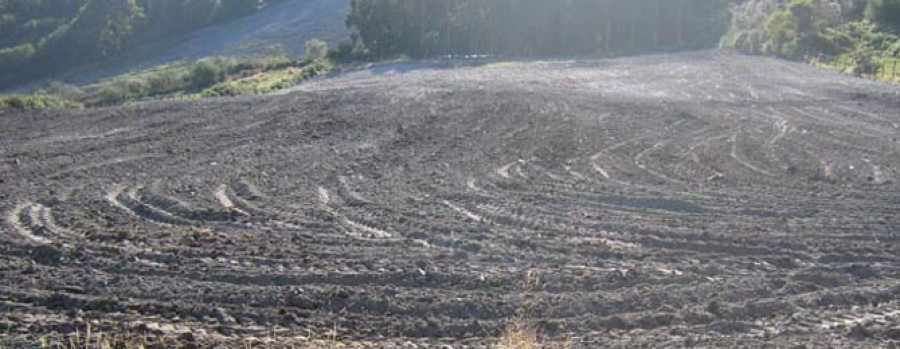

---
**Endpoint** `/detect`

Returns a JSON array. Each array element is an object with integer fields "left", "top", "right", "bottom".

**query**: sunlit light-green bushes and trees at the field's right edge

[{"left": 720, "top": 0, "right": 900, "bottom": 80}]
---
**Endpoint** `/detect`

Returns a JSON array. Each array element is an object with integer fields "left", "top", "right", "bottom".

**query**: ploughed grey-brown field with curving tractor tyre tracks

[{"left": 0, "top": 52, "right": 900, "bottom": 347}]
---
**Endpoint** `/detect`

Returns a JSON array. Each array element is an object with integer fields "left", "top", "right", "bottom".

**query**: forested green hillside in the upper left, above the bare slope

[{"left": 0, "top": 0, "right": 278, "bottom": 86}]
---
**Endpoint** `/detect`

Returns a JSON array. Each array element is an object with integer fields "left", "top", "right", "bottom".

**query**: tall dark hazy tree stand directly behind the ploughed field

[{"left": 347, "top": 0, "right": 730, "bottom": 58}]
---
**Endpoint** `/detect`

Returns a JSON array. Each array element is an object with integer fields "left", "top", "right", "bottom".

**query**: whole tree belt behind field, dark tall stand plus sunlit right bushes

[{"left": 335, "top": 0, "right": 900, "bottom": 75}]
